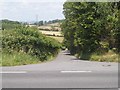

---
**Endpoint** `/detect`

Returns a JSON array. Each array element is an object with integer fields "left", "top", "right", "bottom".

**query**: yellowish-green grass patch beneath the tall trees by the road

[{"left": 90, "top": 51, "right": 119, "bottom": 62}]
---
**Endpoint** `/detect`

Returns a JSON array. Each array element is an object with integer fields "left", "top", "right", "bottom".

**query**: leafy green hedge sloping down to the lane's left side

[{"left": 2, "top": 28, "right": 61, "bottom": 61}]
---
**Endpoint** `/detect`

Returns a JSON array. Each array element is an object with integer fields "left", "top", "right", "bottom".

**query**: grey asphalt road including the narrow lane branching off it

[{"left": 2, "top": 51, "right": 118, "bottom": 90}]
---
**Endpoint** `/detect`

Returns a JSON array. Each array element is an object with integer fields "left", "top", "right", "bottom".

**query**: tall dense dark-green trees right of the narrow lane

[{"left": 61, "top": 2, "right": 120, "bottom": 59}]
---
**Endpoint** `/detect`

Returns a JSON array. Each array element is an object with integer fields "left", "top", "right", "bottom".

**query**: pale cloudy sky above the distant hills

[{"left": 0, "top": 0, "right": 66, "bottom": 22}]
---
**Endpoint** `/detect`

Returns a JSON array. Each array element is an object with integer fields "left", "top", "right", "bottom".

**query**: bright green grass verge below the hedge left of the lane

[{"left": 1, "top": 51, "right": 40, "bottom": 66}]
